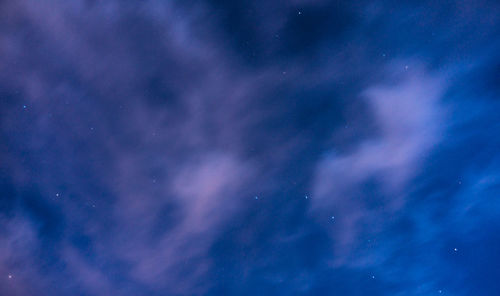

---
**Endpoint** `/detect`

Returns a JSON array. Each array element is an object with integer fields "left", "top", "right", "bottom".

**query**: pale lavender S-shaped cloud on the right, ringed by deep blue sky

[{"left": 312, "top": 63, "right": 446, "bottom": 265}]
